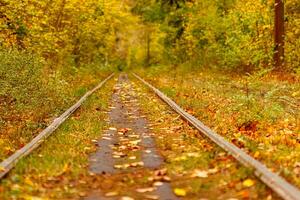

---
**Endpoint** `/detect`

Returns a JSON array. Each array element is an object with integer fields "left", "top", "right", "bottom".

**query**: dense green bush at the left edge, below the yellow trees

[{"left": 0, "top": 49, "right": 47, "bottom": 110}]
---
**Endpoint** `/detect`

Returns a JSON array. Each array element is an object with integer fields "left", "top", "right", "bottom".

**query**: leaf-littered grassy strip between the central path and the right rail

[{"left": 131, "top": 76, "right": 278, "bottom": 199}]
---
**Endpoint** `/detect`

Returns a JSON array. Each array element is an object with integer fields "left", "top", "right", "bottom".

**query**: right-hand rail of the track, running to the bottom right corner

[{"left": 133, "top": 74, "right": 300, "bottom": 200}]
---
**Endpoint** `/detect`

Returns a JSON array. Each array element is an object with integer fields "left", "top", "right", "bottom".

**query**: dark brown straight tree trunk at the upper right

[{"left": 274, "top": 0, "right": 284, "bottom": 71}]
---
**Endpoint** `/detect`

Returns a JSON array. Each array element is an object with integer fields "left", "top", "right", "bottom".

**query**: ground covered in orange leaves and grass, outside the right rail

[{"left": 135, "top": 67, "right": 300, "bottom": 187}]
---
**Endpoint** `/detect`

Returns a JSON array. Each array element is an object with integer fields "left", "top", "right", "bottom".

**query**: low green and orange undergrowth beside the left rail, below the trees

[{"left": 0, "top": 50, "right": 110, "bottom": 161}]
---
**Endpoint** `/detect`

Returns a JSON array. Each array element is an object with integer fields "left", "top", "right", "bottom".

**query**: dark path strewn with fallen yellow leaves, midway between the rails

[{"left": 85, "top": 74, "right": 179, "bottom": 200}]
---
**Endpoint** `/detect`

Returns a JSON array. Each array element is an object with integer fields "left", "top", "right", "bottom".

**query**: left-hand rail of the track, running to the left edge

[{"left": 0, "top": 74, "right": 114, "bottom": 180}]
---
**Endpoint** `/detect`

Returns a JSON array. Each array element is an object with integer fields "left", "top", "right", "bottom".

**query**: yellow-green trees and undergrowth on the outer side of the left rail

[{"left": 0, "top": 0, "right": 118, "bottom": 161}]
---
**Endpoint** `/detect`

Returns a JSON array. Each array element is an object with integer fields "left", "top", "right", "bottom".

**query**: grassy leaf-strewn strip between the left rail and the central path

[{"left": 0, "top": 77, "right": 113, "bottom": 199}]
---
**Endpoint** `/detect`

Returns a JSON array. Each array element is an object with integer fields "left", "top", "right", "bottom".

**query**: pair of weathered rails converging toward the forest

[{"left": 0, "top": 74, "right": 300, "bottom": 200}]
